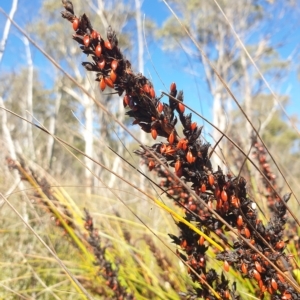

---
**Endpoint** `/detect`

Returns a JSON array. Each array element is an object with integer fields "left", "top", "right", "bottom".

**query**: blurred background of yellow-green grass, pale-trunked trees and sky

[{"left": 0, "top": 0, "right": 300, "bottom": 299}]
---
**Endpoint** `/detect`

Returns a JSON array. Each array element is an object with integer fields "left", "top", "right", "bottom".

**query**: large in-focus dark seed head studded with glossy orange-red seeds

[{"left": 62, "top": 0, "right": 300, "bottom": 300}]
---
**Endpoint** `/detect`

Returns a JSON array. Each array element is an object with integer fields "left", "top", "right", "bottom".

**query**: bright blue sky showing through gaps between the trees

[{"left": 0, "top": 0, "right": 300, "bottom": 136}]
